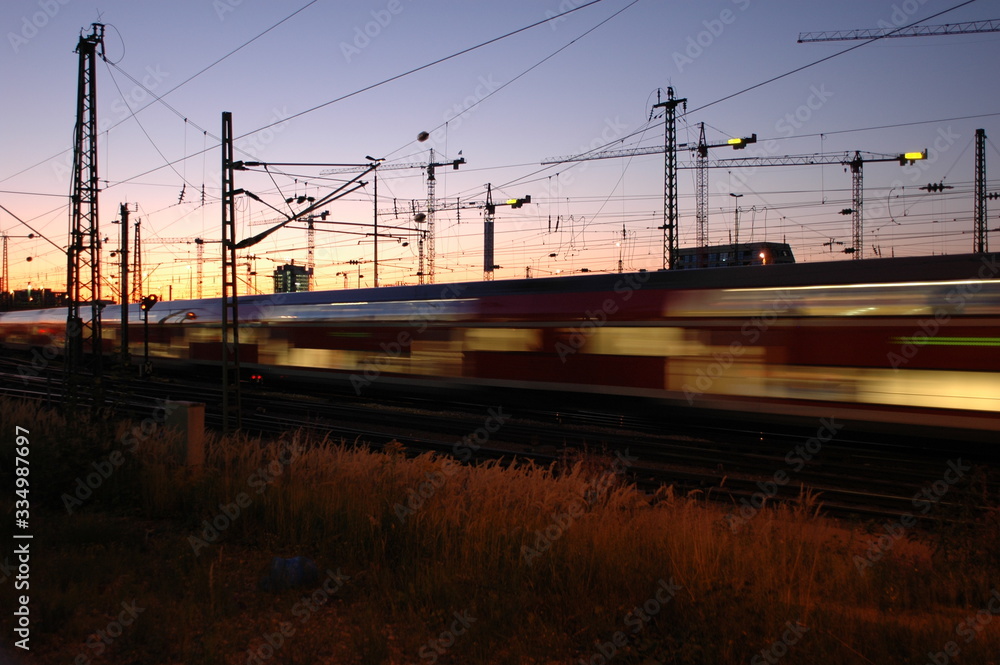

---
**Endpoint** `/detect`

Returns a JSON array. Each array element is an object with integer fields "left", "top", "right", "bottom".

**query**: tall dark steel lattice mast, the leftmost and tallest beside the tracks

[{"left": 66, "top": 23, "right": 104, "bottom": 407}]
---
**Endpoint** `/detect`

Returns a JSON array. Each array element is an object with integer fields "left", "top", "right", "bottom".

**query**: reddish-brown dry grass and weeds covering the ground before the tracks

[{"left": 0, "top": 402, "right": 1000, "bottom": 665}]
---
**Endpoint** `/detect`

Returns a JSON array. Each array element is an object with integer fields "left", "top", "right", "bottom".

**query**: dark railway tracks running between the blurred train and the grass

[{"left": 0, "top": 359, "right": 998, "bottom": 519}]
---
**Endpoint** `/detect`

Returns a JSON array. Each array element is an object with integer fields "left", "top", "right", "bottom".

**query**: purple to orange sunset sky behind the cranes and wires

[{"left": 0, "top": 0, "right": 1000, "bottom": 298}]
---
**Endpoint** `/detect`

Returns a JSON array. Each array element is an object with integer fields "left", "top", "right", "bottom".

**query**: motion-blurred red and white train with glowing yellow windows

[{"left": 0, "top": 254, "right": 1000, "bottom": 432}]
